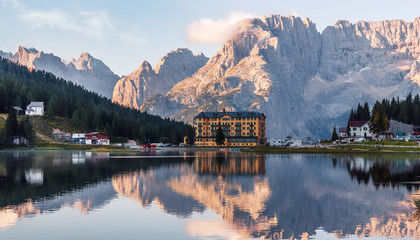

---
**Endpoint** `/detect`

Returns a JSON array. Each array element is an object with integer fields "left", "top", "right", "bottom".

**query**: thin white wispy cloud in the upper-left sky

[{"left": 19, "top": 9, "right": 112, "bottom": 38}]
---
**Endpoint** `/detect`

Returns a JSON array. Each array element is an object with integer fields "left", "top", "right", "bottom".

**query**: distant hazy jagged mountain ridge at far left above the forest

[{"left": 10, "top": 46, "right": 119, "bottom": 98}]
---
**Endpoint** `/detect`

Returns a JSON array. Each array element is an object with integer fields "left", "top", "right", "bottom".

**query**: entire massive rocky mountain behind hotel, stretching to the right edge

[{"left": 114, "top": 15, "right": 420, "bottom": 138}]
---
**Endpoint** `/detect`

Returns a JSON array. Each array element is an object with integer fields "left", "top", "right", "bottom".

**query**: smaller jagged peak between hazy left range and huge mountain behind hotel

[{"left": 112, "top": 49, "right": 208, "bottom": 109}]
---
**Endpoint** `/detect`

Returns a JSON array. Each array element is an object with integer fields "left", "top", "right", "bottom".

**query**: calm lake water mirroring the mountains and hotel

[{"left": 0, "top": 151, "right": 420, "bottom": 240}]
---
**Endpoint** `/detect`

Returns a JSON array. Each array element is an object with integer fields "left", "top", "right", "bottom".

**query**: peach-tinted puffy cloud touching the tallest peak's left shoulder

[{"left": 186, "top": 12, "right": 257, "bottom": 44}]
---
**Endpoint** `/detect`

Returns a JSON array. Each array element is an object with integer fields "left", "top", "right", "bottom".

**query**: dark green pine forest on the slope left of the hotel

[{"left": 0, "top": 58, "right": 192, "bottom": 143}]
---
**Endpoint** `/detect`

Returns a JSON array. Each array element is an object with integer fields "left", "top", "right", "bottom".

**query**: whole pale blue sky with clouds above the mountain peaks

[{"left": 0, "top": 0, "right": 420, "bottom": 75}]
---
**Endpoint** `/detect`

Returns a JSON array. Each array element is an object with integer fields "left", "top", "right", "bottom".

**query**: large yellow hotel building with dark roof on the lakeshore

[{"left": 194, "top": 110, "right": 267, "bottom": 147}]
